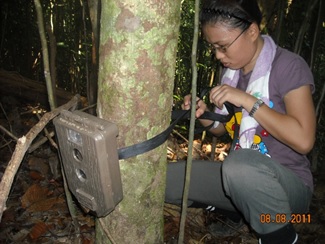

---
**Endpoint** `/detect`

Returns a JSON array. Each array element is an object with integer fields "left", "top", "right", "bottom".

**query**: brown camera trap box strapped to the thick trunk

[{"left": 53, "top": 110, "right": 123, "bottom": 217}]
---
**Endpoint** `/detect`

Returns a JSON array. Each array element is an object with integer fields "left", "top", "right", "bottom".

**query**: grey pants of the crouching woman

[{"left": 165, "top": 149, "right": 312, "bottom": 234}]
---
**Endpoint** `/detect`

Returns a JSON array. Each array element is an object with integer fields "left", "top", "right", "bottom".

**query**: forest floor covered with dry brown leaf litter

[{"left": 0, "top": 97, "right": 325, "bottom": 244}]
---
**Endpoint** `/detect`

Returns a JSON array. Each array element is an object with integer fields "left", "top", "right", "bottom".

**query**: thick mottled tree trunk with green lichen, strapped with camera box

[{"left": 96, "top": 0, "right": 180, "bottom": 244}]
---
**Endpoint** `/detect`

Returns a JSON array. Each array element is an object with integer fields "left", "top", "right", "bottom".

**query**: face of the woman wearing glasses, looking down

[{"left": 202, "top": 23, "right": 257, "bottom": 71}]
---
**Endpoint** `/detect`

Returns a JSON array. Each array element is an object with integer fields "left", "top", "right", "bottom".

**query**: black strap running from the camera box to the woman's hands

[{"left": 118, "top": 103, "right": 234, "bottom": 159}]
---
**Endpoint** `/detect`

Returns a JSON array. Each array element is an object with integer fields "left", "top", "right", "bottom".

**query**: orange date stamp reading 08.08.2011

[{"left": 260, "top": 213, "right": 311, "bottom": 224}]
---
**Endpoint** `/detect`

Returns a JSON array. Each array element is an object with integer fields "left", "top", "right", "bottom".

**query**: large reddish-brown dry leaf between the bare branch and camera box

[{"left": 21, "top": 184, "right": 49, "bottom": 208}]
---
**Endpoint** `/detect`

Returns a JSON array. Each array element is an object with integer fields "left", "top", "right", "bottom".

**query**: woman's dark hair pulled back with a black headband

[{"left": 200, "top": 0, "right": 262, "bottom": 29}]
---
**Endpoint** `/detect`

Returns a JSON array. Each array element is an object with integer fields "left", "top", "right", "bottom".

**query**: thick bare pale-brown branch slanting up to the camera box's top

[{"left": 0, "top": 95, "right": 80, "bottom": 222}]
